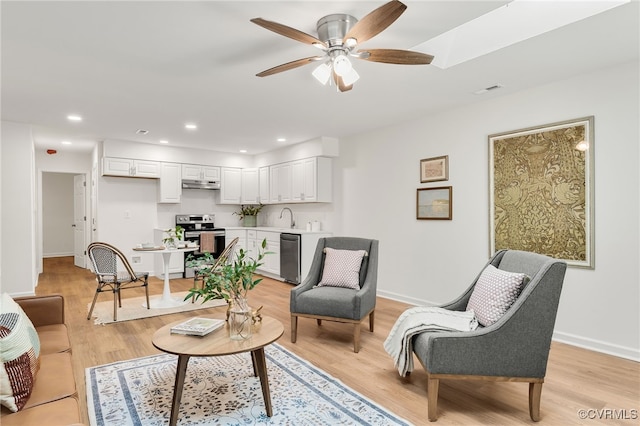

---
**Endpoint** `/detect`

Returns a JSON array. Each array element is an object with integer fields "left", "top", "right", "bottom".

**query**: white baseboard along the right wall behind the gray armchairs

[{"left": 378, "top": 291, "right": 640, "bottom": 362}]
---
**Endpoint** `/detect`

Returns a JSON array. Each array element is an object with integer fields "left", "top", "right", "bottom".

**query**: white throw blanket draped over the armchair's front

[{"left": 384, "top": 306, "right": 478, "bottom": 377}]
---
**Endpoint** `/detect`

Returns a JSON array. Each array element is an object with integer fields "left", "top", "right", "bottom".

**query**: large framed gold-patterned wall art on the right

[{"left": 489, "top": 116, "right": 595, "bottom": 268}]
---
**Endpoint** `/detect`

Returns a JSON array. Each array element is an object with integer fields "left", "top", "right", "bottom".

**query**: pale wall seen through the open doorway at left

[{"left": 42, "top": 173, "right": 74, "bottom": 257}]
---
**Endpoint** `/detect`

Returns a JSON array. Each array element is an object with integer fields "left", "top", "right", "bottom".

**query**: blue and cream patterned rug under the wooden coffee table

[{"left": 86, "top": 344, "right": 410, "bottom": 426}]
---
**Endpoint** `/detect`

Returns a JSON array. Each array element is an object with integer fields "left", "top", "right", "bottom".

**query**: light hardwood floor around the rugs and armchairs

[{"left": 36, "top": 257, "right": 640, "bottom": 425}]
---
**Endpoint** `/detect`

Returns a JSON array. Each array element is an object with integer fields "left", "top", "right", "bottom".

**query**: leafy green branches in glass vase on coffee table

[{"left": 184, "top": 239, "right": 270, "bottom": 340}]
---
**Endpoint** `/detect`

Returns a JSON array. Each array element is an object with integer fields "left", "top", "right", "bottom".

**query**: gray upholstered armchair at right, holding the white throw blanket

[{"left": 413, "top": 250, "right": 567, "bottom": 421}]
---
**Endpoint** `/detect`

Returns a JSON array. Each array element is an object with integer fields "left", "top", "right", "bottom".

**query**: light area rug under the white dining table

[{"left": 87, "top": 291, "right": 227, "bottom": 324}]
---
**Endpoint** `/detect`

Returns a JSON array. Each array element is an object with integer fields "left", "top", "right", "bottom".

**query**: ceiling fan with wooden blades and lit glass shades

[{"left": 251, "top": 0, "right": 433, "bottom": 92}]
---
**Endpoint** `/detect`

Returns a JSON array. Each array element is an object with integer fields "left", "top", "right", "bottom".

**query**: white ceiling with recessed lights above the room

[{"left": 0, "top": 0, "right": 640, "bottom": 154}]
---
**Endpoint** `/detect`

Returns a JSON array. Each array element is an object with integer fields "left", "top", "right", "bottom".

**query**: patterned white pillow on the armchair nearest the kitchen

[{"left": 318, "top": 247, "right": 367, "bottom": 290}]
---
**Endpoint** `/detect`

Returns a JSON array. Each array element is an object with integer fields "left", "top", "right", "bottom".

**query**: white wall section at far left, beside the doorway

[{"left": 0, "top": 121, "right": 38, "bottom": 296}]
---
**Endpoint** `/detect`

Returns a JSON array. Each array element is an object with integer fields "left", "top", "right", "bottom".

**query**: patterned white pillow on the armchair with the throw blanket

[{"left": 467, "top": 265, "right": 527, "bottom": 327}]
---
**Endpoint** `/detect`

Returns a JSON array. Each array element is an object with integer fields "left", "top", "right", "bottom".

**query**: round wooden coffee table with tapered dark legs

[{"left": 152, "top": 315, "right": 284, "bottom": 426}]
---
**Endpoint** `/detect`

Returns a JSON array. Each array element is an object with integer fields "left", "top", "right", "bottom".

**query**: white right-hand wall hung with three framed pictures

[{"left": 335, "top": 62, "right": 640, "bottom": 360}]
